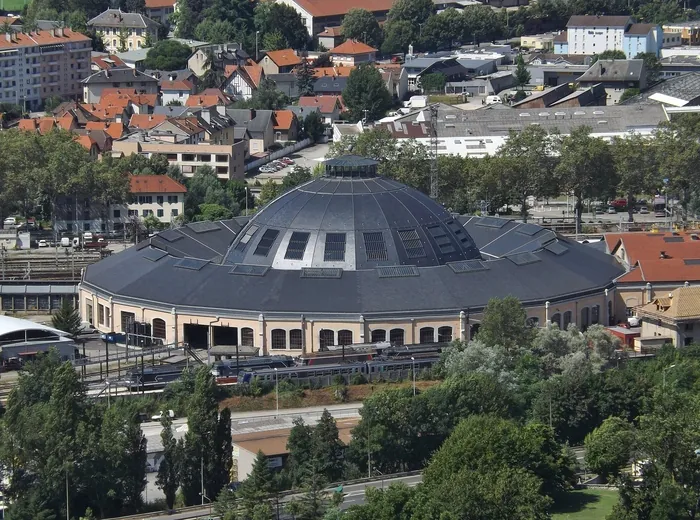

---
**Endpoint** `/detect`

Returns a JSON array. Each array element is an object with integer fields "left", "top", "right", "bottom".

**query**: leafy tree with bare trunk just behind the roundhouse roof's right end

[{"left": 556, "top": 126, "right": 615, "bottom": 233}]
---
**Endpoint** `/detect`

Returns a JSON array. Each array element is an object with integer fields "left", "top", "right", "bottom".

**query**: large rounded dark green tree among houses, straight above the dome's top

[{"left": 343, "top": 64, "right": 391, "bottom": 121}]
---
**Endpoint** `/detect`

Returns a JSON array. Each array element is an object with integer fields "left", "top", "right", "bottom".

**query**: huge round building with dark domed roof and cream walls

[{"left": 80, "top": 156, "right": 625, "bottom": 355}]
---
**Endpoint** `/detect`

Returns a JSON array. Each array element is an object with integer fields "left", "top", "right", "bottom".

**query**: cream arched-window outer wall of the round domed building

[{"left": 80, "top": 284, "right": 614, "bottom": 355}]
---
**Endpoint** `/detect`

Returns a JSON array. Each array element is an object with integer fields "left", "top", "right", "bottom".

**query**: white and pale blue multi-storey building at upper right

[{"left": 554, "top": 15, "right": 663, "bottom": 59}]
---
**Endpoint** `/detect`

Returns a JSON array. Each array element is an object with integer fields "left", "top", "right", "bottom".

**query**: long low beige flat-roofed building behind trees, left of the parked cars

[{"left": 112, "top": 130, "right": 246, "bottom": 180}]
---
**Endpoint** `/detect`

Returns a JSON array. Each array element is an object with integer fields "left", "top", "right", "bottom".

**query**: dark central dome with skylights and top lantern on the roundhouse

[{"left": 225, "top": 156, "right": 481, "bottom": 271}]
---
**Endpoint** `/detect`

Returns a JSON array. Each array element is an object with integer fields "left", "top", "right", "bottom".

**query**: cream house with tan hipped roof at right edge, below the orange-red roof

[{"left": 634, "top": 285, "right": 700, "bottom": 353}]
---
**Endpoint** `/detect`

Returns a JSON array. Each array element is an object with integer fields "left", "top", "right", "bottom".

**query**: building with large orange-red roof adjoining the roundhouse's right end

[{"left": 605, "top": 230, "right": 700, "bottom": 321}]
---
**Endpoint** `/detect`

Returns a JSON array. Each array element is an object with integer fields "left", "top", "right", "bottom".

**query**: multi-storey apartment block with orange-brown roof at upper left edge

[{"left": 0, "top": 27, "right": 92, "bottom": 111}]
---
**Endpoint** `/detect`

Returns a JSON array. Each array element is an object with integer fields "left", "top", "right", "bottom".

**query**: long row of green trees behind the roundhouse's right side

[{"left": 328, "top": 115, "right": 700, "bottom": 232}]
